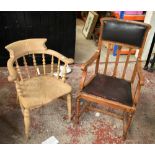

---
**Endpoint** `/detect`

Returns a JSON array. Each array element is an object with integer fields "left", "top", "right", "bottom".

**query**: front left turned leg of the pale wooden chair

[{"left": 24, "top": 109, "right": 30, "bottom": 141}]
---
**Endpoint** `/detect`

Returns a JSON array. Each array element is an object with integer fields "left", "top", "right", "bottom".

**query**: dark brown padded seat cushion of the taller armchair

[{"left": 82, "top": 74, "right": 132, "bottom": 106}]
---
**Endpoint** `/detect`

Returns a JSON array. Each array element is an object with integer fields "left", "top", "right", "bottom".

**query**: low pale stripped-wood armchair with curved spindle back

[{"left": 5, "top": 38, "right": 73, "bottom": 139}]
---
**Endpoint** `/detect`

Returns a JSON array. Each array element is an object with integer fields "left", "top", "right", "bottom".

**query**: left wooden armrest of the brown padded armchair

[{"left": 81, "top": 50, "right": 100, "bottom": 71}]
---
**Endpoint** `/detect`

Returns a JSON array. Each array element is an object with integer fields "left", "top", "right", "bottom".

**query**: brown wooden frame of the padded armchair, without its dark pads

[{"left": 76, "top": 18, "right": 151, "bottom": 139}]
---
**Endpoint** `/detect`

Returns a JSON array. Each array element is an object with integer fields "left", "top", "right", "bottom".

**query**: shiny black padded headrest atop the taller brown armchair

[{"left": 102, "top": 20, "right": 147, "bottom": 47}]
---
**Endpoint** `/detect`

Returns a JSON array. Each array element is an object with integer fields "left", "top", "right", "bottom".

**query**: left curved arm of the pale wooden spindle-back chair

[{"left": 7, "top": 58, "right": 18, "bottom": 82}]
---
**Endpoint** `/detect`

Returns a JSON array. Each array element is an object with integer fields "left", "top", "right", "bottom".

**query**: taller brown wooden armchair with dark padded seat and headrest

[{"left": 76, "top": 18, "right": 150, "bottom": 138}]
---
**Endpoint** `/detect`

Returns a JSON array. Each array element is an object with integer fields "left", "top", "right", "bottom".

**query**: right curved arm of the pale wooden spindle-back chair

[{"left": 46, "top": 49, "right": 74, "bottom": 64}]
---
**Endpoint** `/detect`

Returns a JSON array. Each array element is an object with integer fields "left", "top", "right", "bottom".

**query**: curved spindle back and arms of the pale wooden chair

[{"left": 5, "top": 38, "right": 73, "bottom": 81}]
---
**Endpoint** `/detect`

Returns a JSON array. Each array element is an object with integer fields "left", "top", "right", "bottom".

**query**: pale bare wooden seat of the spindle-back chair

[{"left": 18, "top": 76, "right": 72, "bottom": 109}]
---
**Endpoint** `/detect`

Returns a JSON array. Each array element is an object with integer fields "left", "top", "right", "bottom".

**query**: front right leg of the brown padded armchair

[{"left": 123, "top": 113, "right": 133, "bottom": 140}]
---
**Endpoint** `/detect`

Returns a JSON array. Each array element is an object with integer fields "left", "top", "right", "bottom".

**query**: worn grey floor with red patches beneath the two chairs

[{"left": 0, "top": 64, "right": 155, "bottom": 144}]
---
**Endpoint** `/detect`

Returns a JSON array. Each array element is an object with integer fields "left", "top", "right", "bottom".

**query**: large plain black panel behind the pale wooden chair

[{"left": 0, "top": 11, "right": 76, "bottom": 66}]
